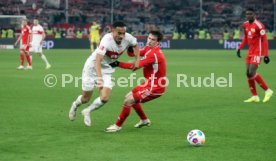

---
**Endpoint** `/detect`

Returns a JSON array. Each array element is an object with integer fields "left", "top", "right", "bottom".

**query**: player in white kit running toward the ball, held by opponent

[{"left": 69, "top": 22, "right": 139, "bottom": 126}]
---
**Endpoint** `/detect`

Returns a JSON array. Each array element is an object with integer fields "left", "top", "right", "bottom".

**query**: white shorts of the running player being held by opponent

[{"left": 82, "top": 59, "right": 113, "bottom": 91}]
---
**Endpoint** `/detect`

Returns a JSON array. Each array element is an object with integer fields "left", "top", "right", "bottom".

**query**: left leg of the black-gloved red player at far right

[{"left": 244, "top": 64, "right": 260, "bottom": 102}]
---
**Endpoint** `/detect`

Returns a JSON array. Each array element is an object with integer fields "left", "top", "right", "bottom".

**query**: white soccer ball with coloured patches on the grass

[{"left": 187, "top": 129, "right": 205, "bottom": 146}]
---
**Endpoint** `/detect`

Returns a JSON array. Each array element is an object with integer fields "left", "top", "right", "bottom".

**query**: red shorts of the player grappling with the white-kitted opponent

[{"left": 132, "top": 85, "right": 165, "bottom": 103}]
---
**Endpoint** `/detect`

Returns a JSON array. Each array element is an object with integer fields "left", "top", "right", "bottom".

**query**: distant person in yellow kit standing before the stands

[{"left": 89, "top": 21, "right": 101, "bottom": 52}]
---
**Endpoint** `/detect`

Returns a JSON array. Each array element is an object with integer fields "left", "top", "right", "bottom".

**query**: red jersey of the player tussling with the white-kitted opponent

[{"left": 119, "top": 46, "right": 166, "bottom": 93}]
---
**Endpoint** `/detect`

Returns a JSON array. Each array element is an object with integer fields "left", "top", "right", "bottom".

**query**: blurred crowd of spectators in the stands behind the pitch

[{"left": 0, "top": 0, "right": 276, "bottom": 40}]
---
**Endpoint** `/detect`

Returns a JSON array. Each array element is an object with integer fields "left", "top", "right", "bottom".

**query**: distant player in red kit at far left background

[{"left": 14, "top": 18, "right": 32, "bottom": 69}]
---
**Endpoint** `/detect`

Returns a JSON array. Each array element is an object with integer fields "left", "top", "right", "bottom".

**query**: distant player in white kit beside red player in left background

[{"left": 30, "top": 19, "right": 51, "bottom": 69}]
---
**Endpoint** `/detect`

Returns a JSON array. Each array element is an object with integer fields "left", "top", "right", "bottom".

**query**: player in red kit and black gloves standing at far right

[{"left": 237, "top": 8, "right": 273, "bottom": 102}]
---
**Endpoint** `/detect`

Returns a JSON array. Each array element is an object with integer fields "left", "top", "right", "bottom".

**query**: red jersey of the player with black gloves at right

[{"left": 239, "top": 20, "right": 268, "bottom": 56}]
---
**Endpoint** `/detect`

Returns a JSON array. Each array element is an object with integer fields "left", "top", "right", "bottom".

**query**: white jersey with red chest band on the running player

[{"left": 88, "top": 33, "right": 137, "bottom": 73}]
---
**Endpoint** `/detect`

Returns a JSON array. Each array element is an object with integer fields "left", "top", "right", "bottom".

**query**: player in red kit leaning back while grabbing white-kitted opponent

[{"left": 105, "top": 31, "right": 166, "bottom": 132}]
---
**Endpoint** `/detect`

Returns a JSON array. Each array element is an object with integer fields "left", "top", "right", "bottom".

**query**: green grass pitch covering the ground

[{"left": 0, "top": 49, "right": 276, "bottom": 161}]
